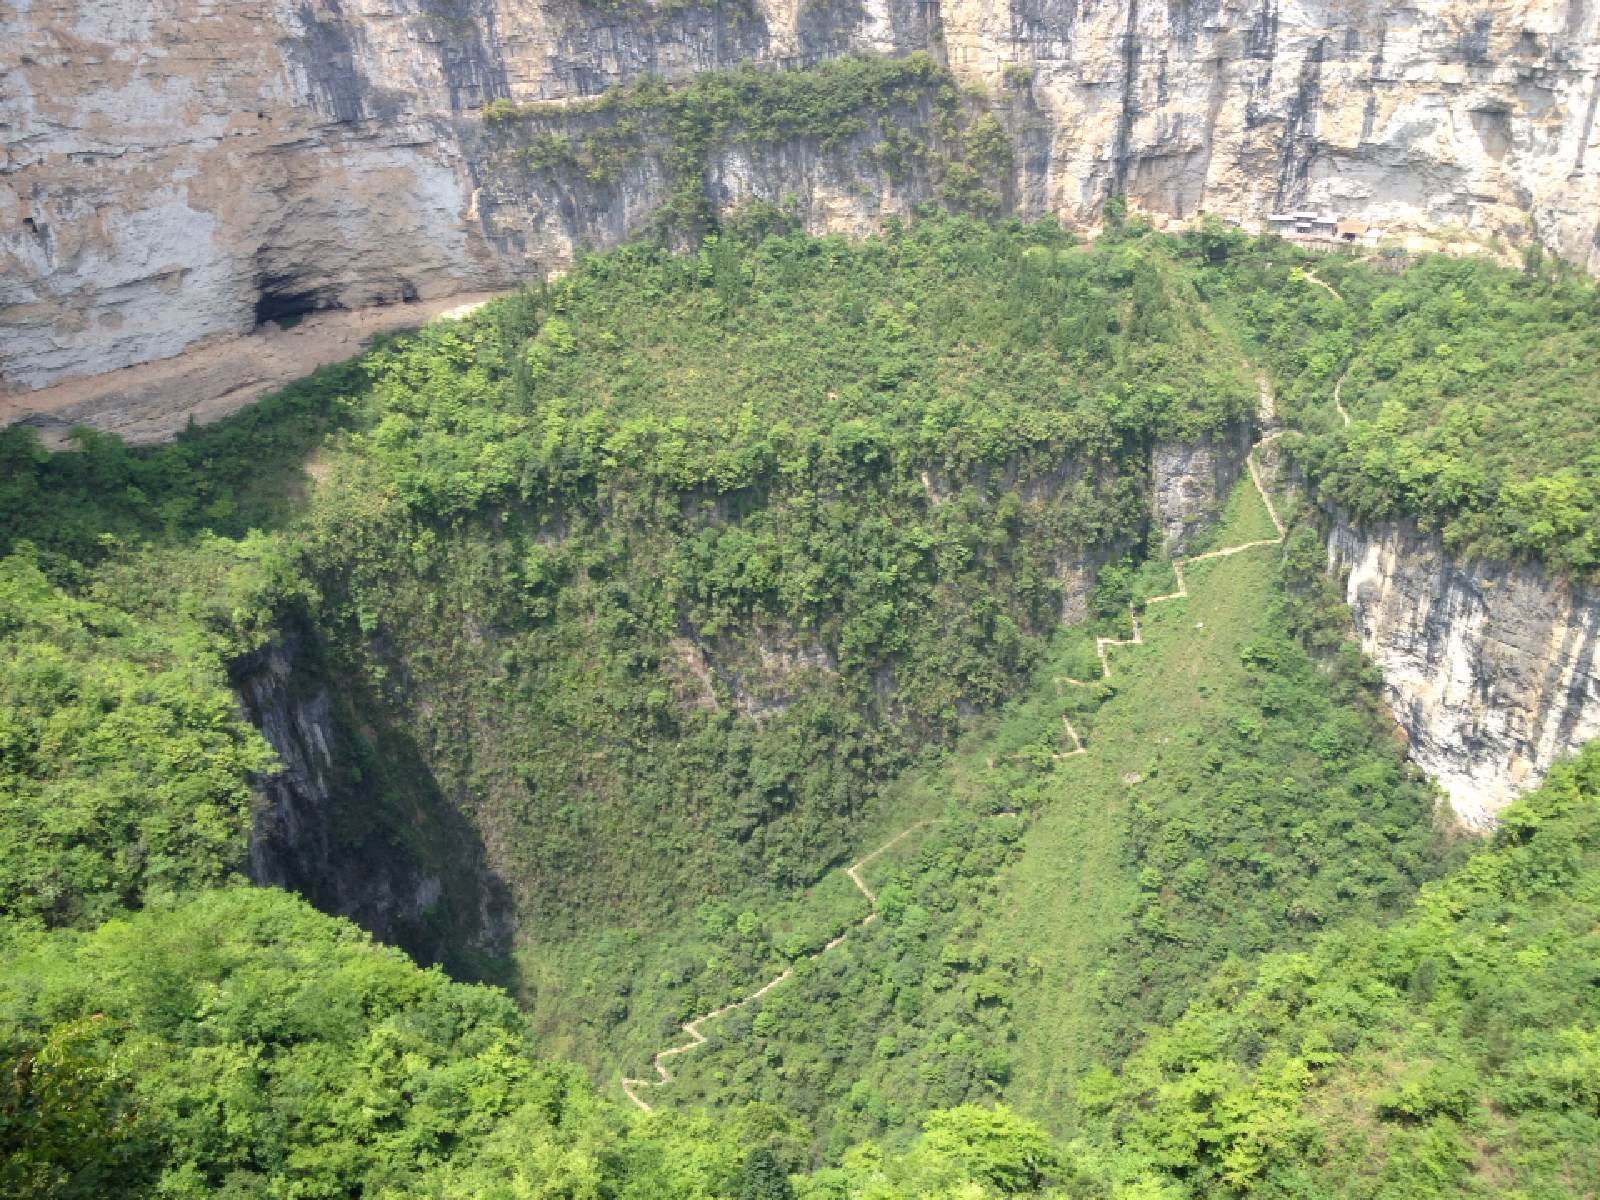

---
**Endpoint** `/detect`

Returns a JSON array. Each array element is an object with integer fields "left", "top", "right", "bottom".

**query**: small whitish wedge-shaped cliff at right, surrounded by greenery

[{"left": 1328, "top": 522, "right": 1600, "bottom": 829}]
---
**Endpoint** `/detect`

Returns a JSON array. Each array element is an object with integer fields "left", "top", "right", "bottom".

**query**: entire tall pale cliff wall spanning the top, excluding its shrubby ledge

[{"left": 0, "top": 0, "right": 1600, "bottom": 389}]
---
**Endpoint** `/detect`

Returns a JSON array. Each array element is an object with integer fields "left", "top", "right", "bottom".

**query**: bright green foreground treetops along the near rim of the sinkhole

[{"left": 0, "top": 750, "right": 1600, "bottom": 1200}]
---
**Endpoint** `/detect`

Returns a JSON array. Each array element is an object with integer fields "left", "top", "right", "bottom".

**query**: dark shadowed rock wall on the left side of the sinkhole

[{"left": 230, "top": 632, "right": 510, "bottom": 976}]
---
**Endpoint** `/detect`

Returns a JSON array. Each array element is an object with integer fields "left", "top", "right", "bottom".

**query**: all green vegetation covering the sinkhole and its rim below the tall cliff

[{"left": 0, "top": 214, "right": 1600, "bottom": 1200}]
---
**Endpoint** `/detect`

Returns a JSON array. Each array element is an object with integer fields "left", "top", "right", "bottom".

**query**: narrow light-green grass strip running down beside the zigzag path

[{"left": 994, "top": 482, "right": 1277, "bottom": 1110}]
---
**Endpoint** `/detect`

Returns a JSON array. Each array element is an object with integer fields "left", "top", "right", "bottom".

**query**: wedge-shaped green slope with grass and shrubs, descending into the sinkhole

[{"left": 617, "top": 482, "right": 1442, "bottom": 1150}]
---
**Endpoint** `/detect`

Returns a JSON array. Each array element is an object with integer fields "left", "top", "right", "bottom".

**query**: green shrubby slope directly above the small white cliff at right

[{"left": 1192, "top": 232, "right": 1600, "bottom": 579}]
